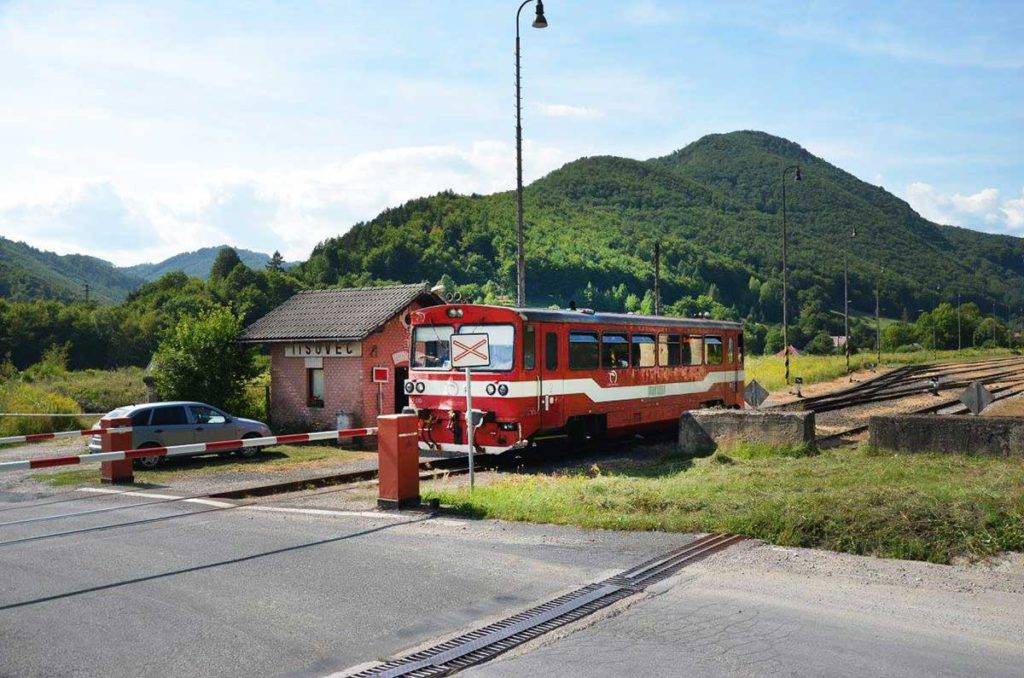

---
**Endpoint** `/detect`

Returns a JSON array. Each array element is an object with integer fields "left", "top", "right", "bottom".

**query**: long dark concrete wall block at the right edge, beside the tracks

[{"left": 868, "top": 415, "right": 1024, "bottom": 457}]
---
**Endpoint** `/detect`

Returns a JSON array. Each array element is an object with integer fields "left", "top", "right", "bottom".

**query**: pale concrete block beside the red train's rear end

[{"left": 678, "top": 410, "right": 815, "bottom": 455}]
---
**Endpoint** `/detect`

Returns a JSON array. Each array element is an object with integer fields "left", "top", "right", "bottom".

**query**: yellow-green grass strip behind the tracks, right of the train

[{"left": 743, "top": 348, "right": 1013, "bottom": 391}]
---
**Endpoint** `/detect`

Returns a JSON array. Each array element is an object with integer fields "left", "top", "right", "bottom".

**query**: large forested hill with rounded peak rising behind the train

[{"left": 297, "top": 131, "right": 1024, "bottom": 320}]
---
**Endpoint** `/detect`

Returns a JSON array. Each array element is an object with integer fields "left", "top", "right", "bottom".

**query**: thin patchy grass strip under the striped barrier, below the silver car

[{"left": 32, "top": 444, "right": 367, "bottom": 488}]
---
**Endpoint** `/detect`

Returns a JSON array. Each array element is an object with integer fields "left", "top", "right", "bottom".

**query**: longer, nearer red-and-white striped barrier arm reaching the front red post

[{"left": 0, "top": 427, "right": 377, "bottom": 472}]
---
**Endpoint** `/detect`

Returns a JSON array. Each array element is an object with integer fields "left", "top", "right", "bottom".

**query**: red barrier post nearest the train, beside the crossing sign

[{"left": 377, "top": 414, "right": 420, "bottom": 509}]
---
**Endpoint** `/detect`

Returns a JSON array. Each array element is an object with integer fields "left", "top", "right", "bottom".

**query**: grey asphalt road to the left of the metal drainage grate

[{"left": 0, "top": 491, "right": 686, "bottom": 676}]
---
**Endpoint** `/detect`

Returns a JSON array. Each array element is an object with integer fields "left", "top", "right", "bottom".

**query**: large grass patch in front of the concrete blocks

[{"left": 424, "top": 448, "right": 1024, "bottom": 563}]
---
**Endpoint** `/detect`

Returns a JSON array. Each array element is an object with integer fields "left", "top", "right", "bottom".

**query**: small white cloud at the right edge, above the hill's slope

[{"left": 906, "top": 181, "right": 1024, "bottom": 231}]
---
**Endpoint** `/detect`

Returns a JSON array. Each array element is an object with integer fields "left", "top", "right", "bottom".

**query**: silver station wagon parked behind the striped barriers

[{"left": 89, "top": 401, "right": 272, "bottom": 468}]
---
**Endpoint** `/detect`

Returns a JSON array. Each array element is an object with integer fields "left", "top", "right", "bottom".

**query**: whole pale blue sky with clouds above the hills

[{"left": 0, "top": 0, "right": 1024, "bottom": 264}]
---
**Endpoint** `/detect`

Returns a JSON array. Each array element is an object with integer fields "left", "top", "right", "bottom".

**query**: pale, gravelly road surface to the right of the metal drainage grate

[{"left": 466, "top": 543, "right": 1024, "bottom": 678}]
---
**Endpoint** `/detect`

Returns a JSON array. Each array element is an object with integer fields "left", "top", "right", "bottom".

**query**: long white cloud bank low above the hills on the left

[{"left": 0, "top": 140, "right": 569, "bottom": 264}]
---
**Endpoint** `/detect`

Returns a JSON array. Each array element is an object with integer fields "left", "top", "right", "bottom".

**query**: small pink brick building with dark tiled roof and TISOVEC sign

[{"left": 242, "top": 284, "right": 441, "bottom": 430}]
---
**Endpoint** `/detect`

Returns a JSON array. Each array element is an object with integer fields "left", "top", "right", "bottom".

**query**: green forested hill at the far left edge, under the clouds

[{"left": 0, "top": 237, "right": 142, "bottom": 303}]
